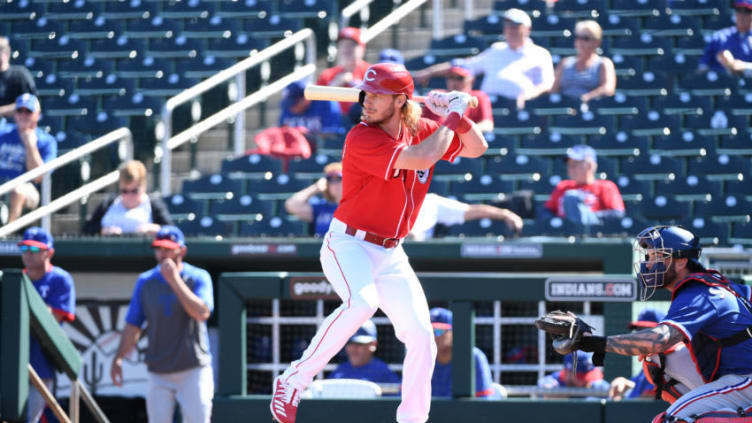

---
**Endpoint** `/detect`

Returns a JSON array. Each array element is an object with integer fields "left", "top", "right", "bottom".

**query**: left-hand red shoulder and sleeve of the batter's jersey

[{"left": 345, "top": 124, "right": 406, "bottom": 181}]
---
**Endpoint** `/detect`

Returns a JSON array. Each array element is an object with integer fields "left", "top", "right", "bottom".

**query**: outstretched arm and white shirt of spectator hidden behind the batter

[{"left": 410, "top": 193, "right": 523, "bottom": 241}]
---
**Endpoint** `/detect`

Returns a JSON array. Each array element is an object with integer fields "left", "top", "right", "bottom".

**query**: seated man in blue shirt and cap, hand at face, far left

[{"left": 0, "top": 94, "right": 57, "bottom": 222}]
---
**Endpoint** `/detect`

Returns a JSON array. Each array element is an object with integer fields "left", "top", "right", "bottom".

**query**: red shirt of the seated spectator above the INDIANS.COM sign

[{"left": 545, "top": 179, "right": 624, "bottom": 217}]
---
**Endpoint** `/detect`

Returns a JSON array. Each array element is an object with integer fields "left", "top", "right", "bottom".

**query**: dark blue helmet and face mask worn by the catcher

[{"left": 634, "top": 226, "right": 703, "bottom": 301}]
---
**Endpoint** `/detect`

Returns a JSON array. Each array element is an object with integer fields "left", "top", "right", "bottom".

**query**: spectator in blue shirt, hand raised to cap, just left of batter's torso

[{"left": 285, "top": 162, "right": 342, "bottom": 237}]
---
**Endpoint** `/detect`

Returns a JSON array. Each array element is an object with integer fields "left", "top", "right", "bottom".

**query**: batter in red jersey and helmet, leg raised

[{"left": 270, "top": 63, "right": 488, "bottom": 423}]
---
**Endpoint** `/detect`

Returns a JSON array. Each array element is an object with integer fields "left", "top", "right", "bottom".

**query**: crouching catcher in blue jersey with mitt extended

[{"left": 536, "top": 226, "right": 752, "bottom": 423}]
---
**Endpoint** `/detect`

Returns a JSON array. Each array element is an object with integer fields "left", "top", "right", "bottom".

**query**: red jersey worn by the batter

[{"left": 334, "top": 119, "right": 462, "bottom": 238}]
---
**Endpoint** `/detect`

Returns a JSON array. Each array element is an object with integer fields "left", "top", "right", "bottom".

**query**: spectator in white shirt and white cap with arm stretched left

[{"left": 415, "top": 9, "right": 554, "bottom": 109}]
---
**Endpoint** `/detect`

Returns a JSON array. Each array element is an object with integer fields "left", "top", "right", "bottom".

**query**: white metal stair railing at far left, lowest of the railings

[{"left": 0, "top": 127, "right": 133, "bottom": 237}]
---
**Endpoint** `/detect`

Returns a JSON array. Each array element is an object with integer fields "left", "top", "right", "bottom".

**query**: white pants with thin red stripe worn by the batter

[{"left": 282, "top": 219, "right": 436, "bottom": 423}]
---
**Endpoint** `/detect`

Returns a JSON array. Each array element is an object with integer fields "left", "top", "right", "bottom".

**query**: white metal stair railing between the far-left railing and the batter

[{"left": 162, "top": 28, "right": 316, "bottom": 196}]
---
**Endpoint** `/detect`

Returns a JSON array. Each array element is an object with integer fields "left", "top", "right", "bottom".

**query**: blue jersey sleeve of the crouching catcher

[{"left": 661, "top": 282, "right": 717, "bottom": 341}]
